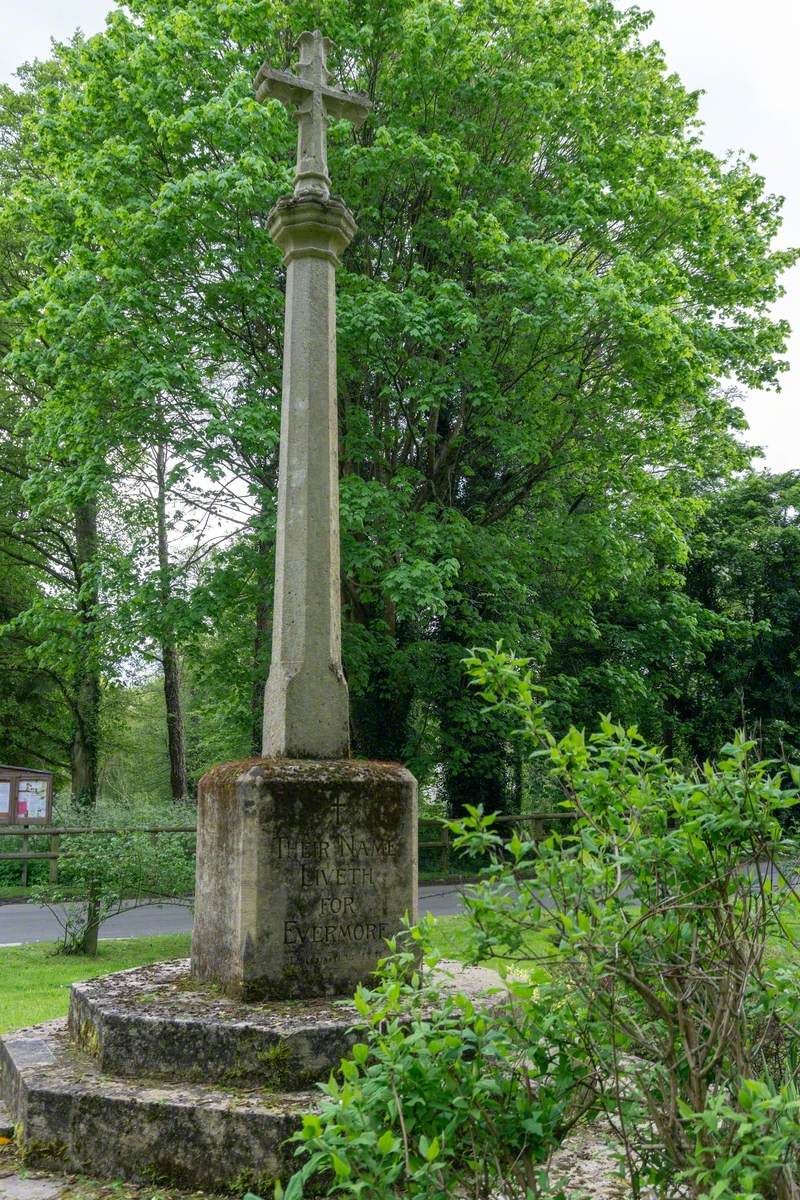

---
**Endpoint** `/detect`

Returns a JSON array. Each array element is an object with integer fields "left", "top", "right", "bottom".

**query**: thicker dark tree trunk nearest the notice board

[{"left": 70, "top": 498, "right": 100, "bottom": 808}]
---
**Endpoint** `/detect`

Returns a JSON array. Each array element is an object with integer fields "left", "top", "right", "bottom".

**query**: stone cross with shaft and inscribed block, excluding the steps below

[{"left": 192, "top": 34, "right": 417, "bottom": 998}]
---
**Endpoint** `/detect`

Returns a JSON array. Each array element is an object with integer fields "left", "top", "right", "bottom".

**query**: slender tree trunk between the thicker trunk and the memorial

[{"left": 156, "top": 445, "right": 188, "bottom": 802}]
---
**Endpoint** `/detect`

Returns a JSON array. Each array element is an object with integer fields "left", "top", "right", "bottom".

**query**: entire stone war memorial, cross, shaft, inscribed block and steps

[{"left": 0, "top": 32, "right": 417, "bottom": 1190}]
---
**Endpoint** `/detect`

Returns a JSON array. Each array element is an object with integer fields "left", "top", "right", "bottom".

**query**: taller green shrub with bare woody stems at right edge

[{"left": 456, "top": 649, "right": 800, "bottom": 1200}]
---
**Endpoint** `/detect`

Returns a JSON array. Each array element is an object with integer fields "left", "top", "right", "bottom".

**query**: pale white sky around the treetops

[{"left": 0, "top": 0, "right": 800, "bottom": 470}]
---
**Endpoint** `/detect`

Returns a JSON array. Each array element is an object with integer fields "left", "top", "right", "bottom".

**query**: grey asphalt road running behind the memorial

[{"left": 0, "top": 883, "right": 462, "bottom": 946}]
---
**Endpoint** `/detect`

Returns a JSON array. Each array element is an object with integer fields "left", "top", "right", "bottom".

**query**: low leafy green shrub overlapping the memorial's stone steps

[{"left": 276, "top": 925, "right": 577, "bottom": 1200}]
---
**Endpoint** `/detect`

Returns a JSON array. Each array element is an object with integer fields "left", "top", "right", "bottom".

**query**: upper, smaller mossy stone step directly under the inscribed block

[{"left": 70, "top": 960, "right": 357, "bottom": 1091}]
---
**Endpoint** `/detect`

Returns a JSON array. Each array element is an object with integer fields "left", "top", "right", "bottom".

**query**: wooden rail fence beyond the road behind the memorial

[{"left": 0, "top": 812, "right": 572, "bottom": 887}]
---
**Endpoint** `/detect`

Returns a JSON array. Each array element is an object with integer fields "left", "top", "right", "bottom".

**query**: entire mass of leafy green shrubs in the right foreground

[{"left": 253, "top": 649, "right": 800, "bottom": 1200}]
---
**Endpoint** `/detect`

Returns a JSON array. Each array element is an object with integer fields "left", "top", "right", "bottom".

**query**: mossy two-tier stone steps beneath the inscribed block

[{"left": 0, "top": 961, "right": 507, "bottom": 1196}]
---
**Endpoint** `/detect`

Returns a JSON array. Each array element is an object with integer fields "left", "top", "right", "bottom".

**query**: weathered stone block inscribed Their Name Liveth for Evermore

[{"left": 192, "top": 758, "right": 417, "bottom": 1001}]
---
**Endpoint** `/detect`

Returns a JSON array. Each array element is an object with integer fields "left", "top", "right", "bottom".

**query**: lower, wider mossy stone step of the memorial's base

[{"left": 0, "top": 1021, "right": 319, "bottom": 1193}]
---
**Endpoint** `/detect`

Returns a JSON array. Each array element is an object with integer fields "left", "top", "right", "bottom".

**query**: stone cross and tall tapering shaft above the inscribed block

[{"left": 255, "top": 31, "right": 371, "bottom": 760}]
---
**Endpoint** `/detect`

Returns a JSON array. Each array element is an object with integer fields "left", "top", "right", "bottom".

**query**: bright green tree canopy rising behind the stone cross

[{"left": 0, "top": 0, "right": 793, "bottom": 810}]
